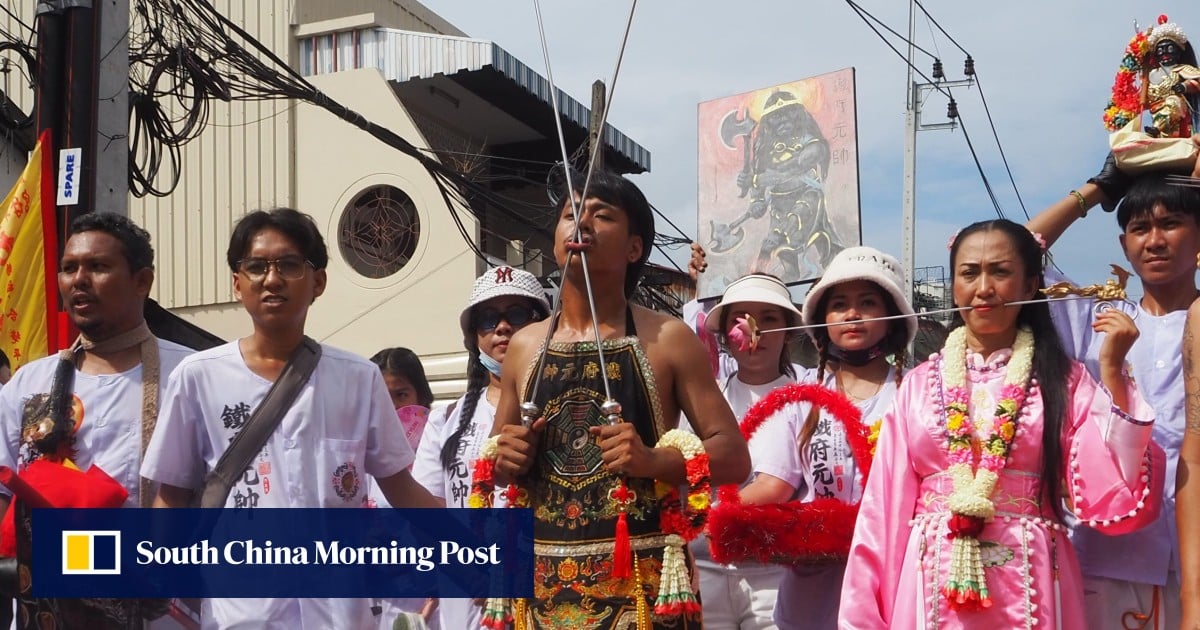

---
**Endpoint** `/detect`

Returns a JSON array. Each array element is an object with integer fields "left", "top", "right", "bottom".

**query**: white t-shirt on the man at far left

[{"left": 0, "top": 340, "right": 193, "bottom": 508}]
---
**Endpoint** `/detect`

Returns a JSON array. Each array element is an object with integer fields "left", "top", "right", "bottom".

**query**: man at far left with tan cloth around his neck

[{"left": 0, "top": 212, "right": 192, "bottom": 628}]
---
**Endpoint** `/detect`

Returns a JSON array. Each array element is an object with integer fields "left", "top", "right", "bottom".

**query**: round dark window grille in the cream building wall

[{"left": 337, "top": 186, "right": 421, "bottom": 278}]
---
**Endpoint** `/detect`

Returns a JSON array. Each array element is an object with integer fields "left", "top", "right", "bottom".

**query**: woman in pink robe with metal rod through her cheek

[{"left": 839, "top": 220, "right": 1164, "bottom": 630}]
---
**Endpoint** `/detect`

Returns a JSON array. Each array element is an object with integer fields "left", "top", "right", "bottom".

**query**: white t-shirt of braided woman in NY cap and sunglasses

[{"left": 413, "top": 390, "right": 492, "bottom": 630}]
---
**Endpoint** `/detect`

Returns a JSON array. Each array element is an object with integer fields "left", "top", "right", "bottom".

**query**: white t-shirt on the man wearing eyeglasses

[{"left": 142, "top": 341, "right": 413, "bottom": 630}]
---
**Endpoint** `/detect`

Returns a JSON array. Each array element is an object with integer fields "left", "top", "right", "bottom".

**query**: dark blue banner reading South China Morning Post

[{"left": 31, "top": 509, "right": 533, "bottom": 598}]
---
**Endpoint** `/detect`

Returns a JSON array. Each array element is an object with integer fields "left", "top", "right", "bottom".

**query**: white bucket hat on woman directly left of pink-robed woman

[{"left": 803, "top": 247, "right": 917, "bottom": 350}]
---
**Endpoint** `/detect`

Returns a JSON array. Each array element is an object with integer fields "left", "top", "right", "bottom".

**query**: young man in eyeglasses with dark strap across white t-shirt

[{"left": 142, "top": 208, "right": 438, "bottom": 629}]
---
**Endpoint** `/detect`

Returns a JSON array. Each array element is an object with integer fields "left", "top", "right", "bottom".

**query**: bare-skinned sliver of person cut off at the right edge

[{"left": 1175, "top": 300, "right": 1200, "bottom": 630}]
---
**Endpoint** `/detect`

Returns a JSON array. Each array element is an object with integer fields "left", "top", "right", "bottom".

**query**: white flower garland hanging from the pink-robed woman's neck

[{"left": 937, "top": 326, "right": 1033, "bottom": 610}]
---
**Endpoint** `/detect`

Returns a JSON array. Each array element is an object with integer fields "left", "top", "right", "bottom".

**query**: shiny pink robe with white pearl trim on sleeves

[{"left": 839, "top": 350, "right": 1165, "bottom": 630}]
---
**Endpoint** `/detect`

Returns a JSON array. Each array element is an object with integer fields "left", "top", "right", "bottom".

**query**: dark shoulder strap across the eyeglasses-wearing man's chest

[{"left": 196, "top": 336, "right": 320, "bottom": 508}]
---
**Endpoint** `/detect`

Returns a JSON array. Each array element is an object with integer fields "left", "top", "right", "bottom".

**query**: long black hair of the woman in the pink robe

[{"left": 950, "top": 218, "right": 1070, "bottom": 520}]
